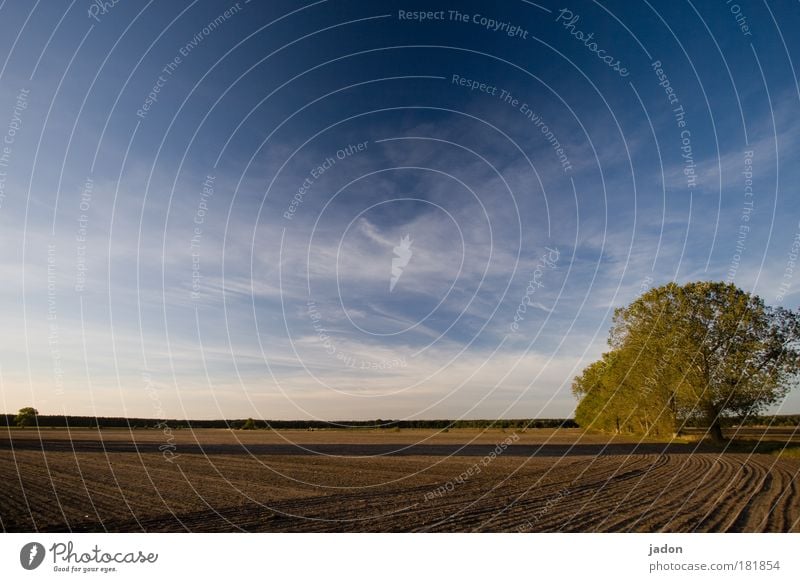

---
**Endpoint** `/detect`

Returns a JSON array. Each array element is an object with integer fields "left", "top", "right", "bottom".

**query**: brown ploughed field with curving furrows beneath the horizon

[{"left": 0, "top": 428, "right": 800, "bottom": 532}]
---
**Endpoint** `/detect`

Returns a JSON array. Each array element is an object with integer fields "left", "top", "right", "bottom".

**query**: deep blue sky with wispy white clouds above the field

[{"left": 0, "top": 0, "right": 800, "bottom": 420}]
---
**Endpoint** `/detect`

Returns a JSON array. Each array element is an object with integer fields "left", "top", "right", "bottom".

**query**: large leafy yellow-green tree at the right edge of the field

[{"left": 572, "top": 282, "right": 800, "bottom": 440}]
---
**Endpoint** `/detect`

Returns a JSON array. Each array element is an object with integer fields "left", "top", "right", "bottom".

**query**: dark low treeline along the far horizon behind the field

[{"left": 0, "top": 414, "right": 800, "bottom": 430}]
